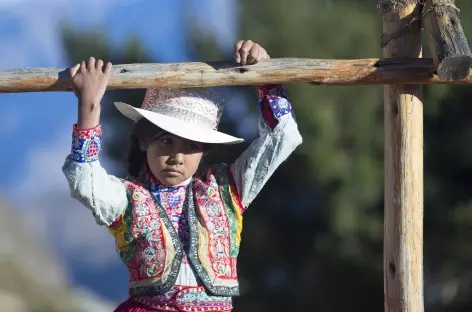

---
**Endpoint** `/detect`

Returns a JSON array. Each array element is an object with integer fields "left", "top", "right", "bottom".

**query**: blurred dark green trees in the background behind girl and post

[{"left": 63, "top": 0, "right": 472, "bottom": 312}]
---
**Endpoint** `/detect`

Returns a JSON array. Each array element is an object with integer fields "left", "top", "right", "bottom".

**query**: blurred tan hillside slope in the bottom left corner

[{"left": 0, "top": 198, "right": 113, "bottom": 312}]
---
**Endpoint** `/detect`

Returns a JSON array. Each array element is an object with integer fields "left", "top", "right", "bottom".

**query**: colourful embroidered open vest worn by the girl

[{"left": 109, "top": 165, "right": 243, "bottom": 296}]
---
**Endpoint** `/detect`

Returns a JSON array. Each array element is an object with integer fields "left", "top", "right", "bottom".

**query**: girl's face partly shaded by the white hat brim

[{"left": 145, "top": 132, "right": 204, "bottom": 186}]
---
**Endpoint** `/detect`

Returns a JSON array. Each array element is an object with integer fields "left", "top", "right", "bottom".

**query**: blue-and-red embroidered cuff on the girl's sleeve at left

[{"left": 71, "top": 124, "right": 102, "bottom": 163}]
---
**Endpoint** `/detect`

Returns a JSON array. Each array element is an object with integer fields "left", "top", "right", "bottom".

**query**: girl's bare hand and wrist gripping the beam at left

[{"left": 69, "top": 57, "right": 112, "bottom": 128}]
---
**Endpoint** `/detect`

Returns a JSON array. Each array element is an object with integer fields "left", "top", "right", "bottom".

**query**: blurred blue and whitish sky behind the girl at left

[{"left": 0, "top": 0, "right": 236, "bottom": 300}]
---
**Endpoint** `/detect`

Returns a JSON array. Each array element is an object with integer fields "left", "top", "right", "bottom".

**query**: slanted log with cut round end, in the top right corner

[{"left": 422, "top": 0, "right": 472, "bottom": 81}]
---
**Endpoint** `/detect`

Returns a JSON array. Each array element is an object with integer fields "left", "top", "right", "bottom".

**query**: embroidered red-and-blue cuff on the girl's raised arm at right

[{"left": 258, "top": 85, "right": 292, "bottom": 128}]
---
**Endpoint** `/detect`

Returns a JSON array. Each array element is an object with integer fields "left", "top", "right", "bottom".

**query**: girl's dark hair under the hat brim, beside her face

[{"left": 126, "top": 118, "right": 213, "bottom": 178}]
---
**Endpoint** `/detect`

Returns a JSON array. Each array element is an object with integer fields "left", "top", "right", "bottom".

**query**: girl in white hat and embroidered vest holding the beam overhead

[{"left": 63, "top": 40, "right": 302, "bottom": 312}]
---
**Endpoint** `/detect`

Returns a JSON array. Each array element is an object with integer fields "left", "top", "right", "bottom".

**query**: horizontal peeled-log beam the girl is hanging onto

[{"left": 0, "top": 58, "right": 472, "bottom": 93}]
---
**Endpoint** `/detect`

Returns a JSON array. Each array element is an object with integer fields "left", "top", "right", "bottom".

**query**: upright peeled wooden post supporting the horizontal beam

[{"left": 380, "top": 0, "right": 424, "bottom": 312}]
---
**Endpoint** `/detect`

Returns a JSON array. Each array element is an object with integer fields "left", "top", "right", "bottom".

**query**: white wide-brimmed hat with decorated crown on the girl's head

[{"left": 115, "top": 88, "right": 244, "bottom": 144}]
